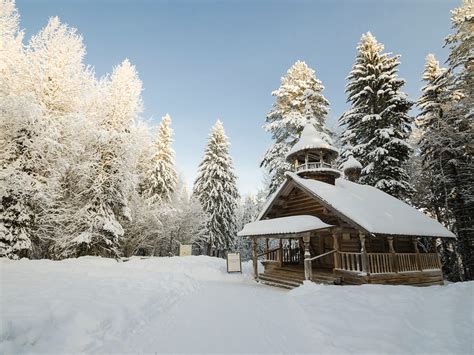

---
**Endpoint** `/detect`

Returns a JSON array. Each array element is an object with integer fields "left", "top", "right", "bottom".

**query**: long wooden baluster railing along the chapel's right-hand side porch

[{"left": 336, "top": 252, "right": 441, "bottom": 274}]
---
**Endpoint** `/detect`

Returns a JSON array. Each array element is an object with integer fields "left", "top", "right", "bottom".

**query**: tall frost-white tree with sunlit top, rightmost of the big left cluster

[{"left": 56, "top": 60, "right": 142, "bottom": 257}]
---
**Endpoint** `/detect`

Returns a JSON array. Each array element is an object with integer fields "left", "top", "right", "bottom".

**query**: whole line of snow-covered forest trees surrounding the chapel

[{"left": 0, "top": 0, "right": 474, "bottom": 280}]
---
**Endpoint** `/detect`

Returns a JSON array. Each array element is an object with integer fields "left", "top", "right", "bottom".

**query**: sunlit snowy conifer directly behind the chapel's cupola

[{"left": 261, "top": 61, "right": 329, "bottom": 192}]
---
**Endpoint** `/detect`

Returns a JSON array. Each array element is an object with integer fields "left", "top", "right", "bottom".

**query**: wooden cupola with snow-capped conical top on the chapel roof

[{"left": 286, "top": 121, "right": 341, "bottom": 185}]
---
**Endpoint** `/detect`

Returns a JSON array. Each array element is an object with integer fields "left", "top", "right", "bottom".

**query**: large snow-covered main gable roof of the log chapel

[{"left": 259, "top": 172, "right": 456, "bottom": 238}]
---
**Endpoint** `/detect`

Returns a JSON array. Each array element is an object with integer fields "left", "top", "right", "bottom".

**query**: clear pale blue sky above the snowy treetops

[{"left": 17, "top": 0, "right": 461, "bottom": 194}]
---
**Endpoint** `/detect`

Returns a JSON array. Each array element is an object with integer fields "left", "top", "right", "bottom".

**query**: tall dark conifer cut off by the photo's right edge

[{"left": 440, "top": 0, "right": 474, "bottom": 280}]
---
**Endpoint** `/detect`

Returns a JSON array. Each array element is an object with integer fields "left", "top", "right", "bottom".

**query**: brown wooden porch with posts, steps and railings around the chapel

[{"left": 253, "top": 233, "right": 443, "bottom": 288}]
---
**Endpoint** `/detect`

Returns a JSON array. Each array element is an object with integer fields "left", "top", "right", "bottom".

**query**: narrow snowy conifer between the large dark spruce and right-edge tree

[{"left": 411, "top": 54, "right": 460, "bottom": 281}]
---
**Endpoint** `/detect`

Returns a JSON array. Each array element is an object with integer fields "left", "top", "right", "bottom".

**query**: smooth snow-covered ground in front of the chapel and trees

[{"left": 0, "top": 256, "right": 474, "bottom": 354}]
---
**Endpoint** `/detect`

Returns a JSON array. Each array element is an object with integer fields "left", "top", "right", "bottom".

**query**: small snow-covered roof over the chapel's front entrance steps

[{"left": 237, "top": 215, "right": 332, "bottom": 237}]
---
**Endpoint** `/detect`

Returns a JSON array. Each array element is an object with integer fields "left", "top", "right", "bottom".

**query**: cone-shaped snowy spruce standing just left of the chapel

[{"left": 193, "top": 121, "right": 239, "bottom": 255}]
